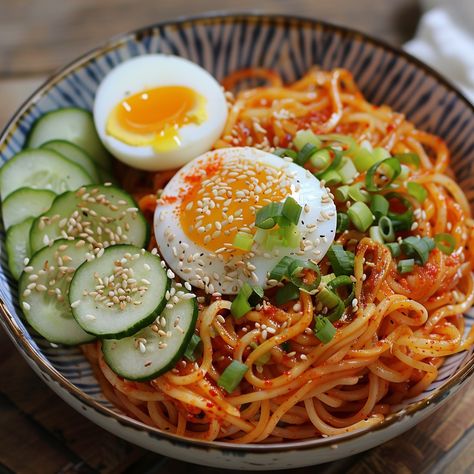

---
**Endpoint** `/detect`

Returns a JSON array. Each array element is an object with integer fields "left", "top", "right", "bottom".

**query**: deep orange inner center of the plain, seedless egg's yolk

[{"left": 116, "top": 86, "right": 200, "bottom": 134}]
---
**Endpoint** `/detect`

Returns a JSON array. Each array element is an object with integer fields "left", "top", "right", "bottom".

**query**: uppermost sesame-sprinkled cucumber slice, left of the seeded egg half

[{"left": 30, "top": 185, "right": 149, "bottom": 252}]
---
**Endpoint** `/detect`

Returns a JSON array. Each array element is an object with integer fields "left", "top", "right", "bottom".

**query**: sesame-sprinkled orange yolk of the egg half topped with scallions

[{"left": 179, "top": 157, "right": 290, "bottom": 253}]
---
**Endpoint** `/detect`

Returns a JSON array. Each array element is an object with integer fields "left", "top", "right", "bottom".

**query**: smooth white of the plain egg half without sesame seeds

[{"left": 94, "top": 54, "right": 227, "bottom": 171}]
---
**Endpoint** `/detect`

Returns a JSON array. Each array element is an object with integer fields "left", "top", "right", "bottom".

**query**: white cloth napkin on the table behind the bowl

[{"left": 405, "top": 0, "right": 474, "bottom": 103}]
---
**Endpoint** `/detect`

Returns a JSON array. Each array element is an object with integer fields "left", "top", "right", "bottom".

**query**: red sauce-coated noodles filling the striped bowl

[{"left": 84, "top": 69, "right": 474, "bottom": 443}]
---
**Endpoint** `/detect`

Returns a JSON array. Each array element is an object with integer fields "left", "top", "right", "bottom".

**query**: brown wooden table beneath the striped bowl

[{"left": 0, "top": 0, "right": 474, "bottom": 474}]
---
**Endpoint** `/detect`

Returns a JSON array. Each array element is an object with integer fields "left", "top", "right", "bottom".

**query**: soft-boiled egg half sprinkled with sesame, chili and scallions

[{"left": 154, "top": 147, "right": 336, "bottom": 294}]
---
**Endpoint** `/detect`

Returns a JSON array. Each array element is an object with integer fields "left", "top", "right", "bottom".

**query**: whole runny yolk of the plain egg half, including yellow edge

[{"left": 106, "top": 86, "right": 207, "bottom": 151}]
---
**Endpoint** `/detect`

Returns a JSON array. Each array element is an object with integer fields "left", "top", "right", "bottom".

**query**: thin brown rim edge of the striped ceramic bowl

[{"left": 0, "top": 11, "right": 474, "bottom": 453}]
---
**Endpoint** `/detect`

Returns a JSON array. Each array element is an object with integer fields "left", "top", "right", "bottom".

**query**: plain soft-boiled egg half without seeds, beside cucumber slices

[{"left": 94, "top": 54, "right": 227, "bottom": 171}]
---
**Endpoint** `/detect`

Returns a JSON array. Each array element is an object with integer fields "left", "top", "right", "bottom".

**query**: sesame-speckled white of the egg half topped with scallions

[{"left": 154, "top": 147, "right": 336, "bottom": 294}]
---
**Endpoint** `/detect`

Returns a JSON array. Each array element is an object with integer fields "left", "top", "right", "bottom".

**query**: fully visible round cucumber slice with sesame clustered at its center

[{"left": 69, "top": 245, "right": 171, "bottom": 339}]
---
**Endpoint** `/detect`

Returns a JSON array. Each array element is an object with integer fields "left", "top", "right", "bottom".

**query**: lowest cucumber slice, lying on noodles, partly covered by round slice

[{"left": 102, "top": 288, "right": 198, "bottom": 382}]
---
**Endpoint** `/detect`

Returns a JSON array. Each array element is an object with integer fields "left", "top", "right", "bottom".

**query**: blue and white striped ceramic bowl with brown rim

[{"left": 0, "top": 15, "right": 474, "bottom": 470}]
